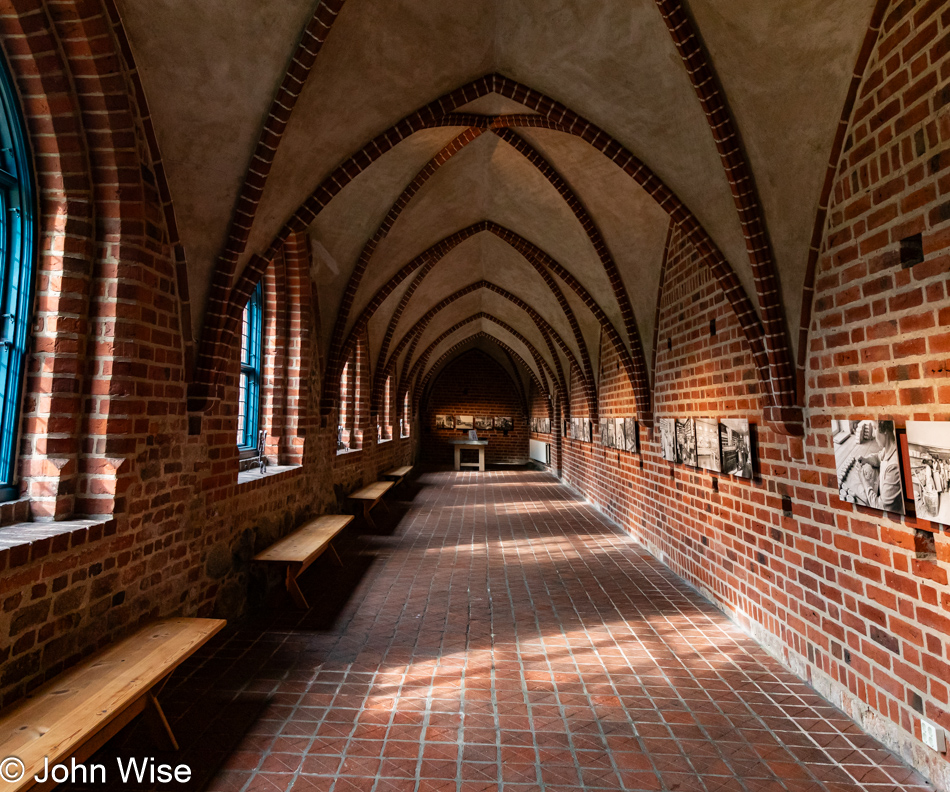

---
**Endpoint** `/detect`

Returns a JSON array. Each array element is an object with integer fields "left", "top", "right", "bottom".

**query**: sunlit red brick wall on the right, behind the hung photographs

[{"left": 564, "top": 3, "right": 950, "bottom": 787}]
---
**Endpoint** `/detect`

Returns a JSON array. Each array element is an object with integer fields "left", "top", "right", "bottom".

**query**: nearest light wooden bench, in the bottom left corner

[{"left": 0, "top": 618, "right": 225, "bottom": 792}]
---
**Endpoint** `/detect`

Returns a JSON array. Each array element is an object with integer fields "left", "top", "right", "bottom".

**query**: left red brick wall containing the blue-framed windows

[{"left": 0, "top": 6, "right": 411, "bottom": 706}]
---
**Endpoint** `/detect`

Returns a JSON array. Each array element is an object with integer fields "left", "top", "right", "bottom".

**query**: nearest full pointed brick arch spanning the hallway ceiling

[{"left": 199, "top": 74, "right": 801, "bottom": 433}]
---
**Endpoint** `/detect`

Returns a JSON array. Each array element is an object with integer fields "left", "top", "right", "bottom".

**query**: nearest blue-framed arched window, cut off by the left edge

[{"left": 0, "top": 59, "right": 35, "bottom": 501}]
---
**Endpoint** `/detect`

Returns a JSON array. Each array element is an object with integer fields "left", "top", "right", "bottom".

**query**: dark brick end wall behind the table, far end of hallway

[{"left": 420, "top": 350, "right": 529, "bottom": 464}]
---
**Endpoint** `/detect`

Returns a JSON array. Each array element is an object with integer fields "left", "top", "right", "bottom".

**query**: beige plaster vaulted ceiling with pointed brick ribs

[{"left": 117, "top": 0, "right": 873, "bottom": 420}]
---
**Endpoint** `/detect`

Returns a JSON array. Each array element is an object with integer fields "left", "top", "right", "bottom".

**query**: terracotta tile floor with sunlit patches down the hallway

[{"left": 85, "top": 471, "right": 932, "bottom": 792}]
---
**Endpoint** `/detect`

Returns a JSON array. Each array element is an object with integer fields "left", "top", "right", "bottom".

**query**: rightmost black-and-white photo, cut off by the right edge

[{"left": 907, "top": 421, "right": 950, "bottom": 525}]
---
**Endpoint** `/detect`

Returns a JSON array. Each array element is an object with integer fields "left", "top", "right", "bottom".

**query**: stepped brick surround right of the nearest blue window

[{"left": 0, "top": 0, "right": 181, "bottom": 517}]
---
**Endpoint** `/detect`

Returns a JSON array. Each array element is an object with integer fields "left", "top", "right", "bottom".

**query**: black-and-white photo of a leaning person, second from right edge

[{"left": 831, "top": 419, "right": 905, "bottom": 514}]
